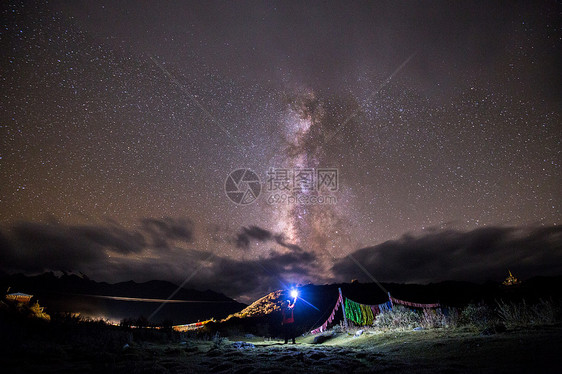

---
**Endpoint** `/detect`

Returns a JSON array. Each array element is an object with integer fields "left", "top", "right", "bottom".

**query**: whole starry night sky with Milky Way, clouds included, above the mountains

[{"left": 0, "top": 1, "right": 562, "bottom": 301}]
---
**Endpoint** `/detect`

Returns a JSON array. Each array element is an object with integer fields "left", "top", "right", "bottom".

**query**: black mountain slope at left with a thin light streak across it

[{"left": 0, "top": 272, "right": 246, "bottom": 324}]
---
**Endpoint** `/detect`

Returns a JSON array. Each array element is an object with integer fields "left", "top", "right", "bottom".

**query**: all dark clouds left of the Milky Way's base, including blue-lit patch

[{"left": 0, "top": 218, "right": 318, "bottom": 301}]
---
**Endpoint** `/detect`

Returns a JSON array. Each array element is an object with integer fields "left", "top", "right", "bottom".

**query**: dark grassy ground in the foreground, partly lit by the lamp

[{"left": 1, "top": 326, "right": 562, "bottom": 374}]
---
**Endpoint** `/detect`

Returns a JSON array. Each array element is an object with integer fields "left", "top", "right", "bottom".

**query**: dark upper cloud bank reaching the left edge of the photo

[{"left": 0, "top": 218, "right": 193, "bottom": 271}]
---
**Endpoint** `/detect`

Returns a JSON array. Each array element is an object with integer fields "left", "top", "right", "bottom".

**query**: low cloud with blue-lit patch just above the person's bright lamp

[{"left": 95, "top": 249, "right": 318, "bottom": 302}]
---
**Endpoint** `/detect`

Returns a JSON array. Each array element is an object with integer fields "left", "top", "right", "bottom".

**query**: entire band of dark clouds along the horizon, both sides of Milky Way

[{"left": 0, "top": 219, "right": 562, "bottom": 301}]
